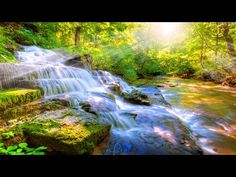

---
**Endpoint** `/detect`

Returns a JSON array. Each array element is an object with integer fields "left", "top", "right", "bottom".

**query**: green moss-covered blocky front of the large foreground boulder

[{"left": 21, "top": 119, "right": 110, "bottom": 155}]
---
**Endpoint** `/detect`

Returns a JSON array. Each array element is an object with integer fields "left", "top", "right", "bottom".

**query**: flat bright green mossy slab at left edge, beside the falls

[{"left": 0, "top": 89, "right": 42, "bottom": 112}]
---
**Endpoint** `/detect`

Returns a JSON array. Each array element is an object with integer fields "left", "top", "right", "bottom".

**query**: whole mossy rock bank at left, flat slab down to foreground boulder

[{"left": 0, "top": 89, "right": 110, "bottom": 154}]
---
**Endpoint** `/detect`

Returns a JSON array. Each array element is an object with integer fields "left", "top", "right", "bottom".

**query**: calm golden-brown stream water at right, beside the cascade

[{"left": 156, "top": 77, "right": 236, "bottom": 154}]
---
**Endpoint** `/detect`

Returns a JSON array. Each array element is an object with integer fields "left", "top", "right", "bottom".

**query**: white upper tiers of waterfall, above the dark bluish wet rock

[{"left": 12, "top": 46, "right": 137, "bottom": 131}]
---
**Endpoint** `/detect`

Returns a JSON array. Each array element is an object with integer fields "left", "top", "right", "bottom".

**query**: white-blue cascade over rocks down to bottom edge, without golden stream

[{"left": 5, "top": 46, "right": 203, "bottom": 154}]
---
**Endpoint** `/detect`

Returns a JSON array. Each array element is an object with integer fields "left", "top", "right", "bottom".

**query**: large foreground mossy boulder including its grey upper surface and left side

[{"left": 0, "top": 106, "right": 110, "bottom": 154}]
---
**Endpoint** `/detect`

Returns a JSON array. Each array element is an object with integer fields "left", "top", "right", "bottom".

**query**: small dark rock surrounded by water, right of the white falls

[{"left": 121, "top": 90, "right": 150, "bottom": 105}]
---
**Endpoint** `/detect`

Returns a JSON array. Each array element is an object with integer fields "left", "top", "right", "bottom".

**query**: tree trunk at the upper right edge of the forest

[{"left": 222, "top": 22, "right": 236, "bottom": 68}]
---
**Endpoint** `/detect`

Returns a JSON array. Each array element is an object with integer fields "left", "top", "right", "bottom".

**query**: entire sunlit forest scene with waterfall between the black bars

[{"left": 0, "top": 22, "right": 236, "bottom": 155}]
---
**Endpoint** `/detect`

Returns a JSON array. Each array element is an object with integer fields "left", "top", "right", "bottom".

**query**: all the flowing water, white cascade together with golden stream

[{"left": 0, "top": 46, "right": 236, "bottom": 155}]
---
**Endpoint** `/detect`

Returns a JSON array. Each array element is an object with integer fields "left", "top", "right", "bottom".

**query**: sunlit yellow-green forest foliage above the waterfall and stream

[{"left": 0, "top": 22, "right": 236, "bottom": 85}]
